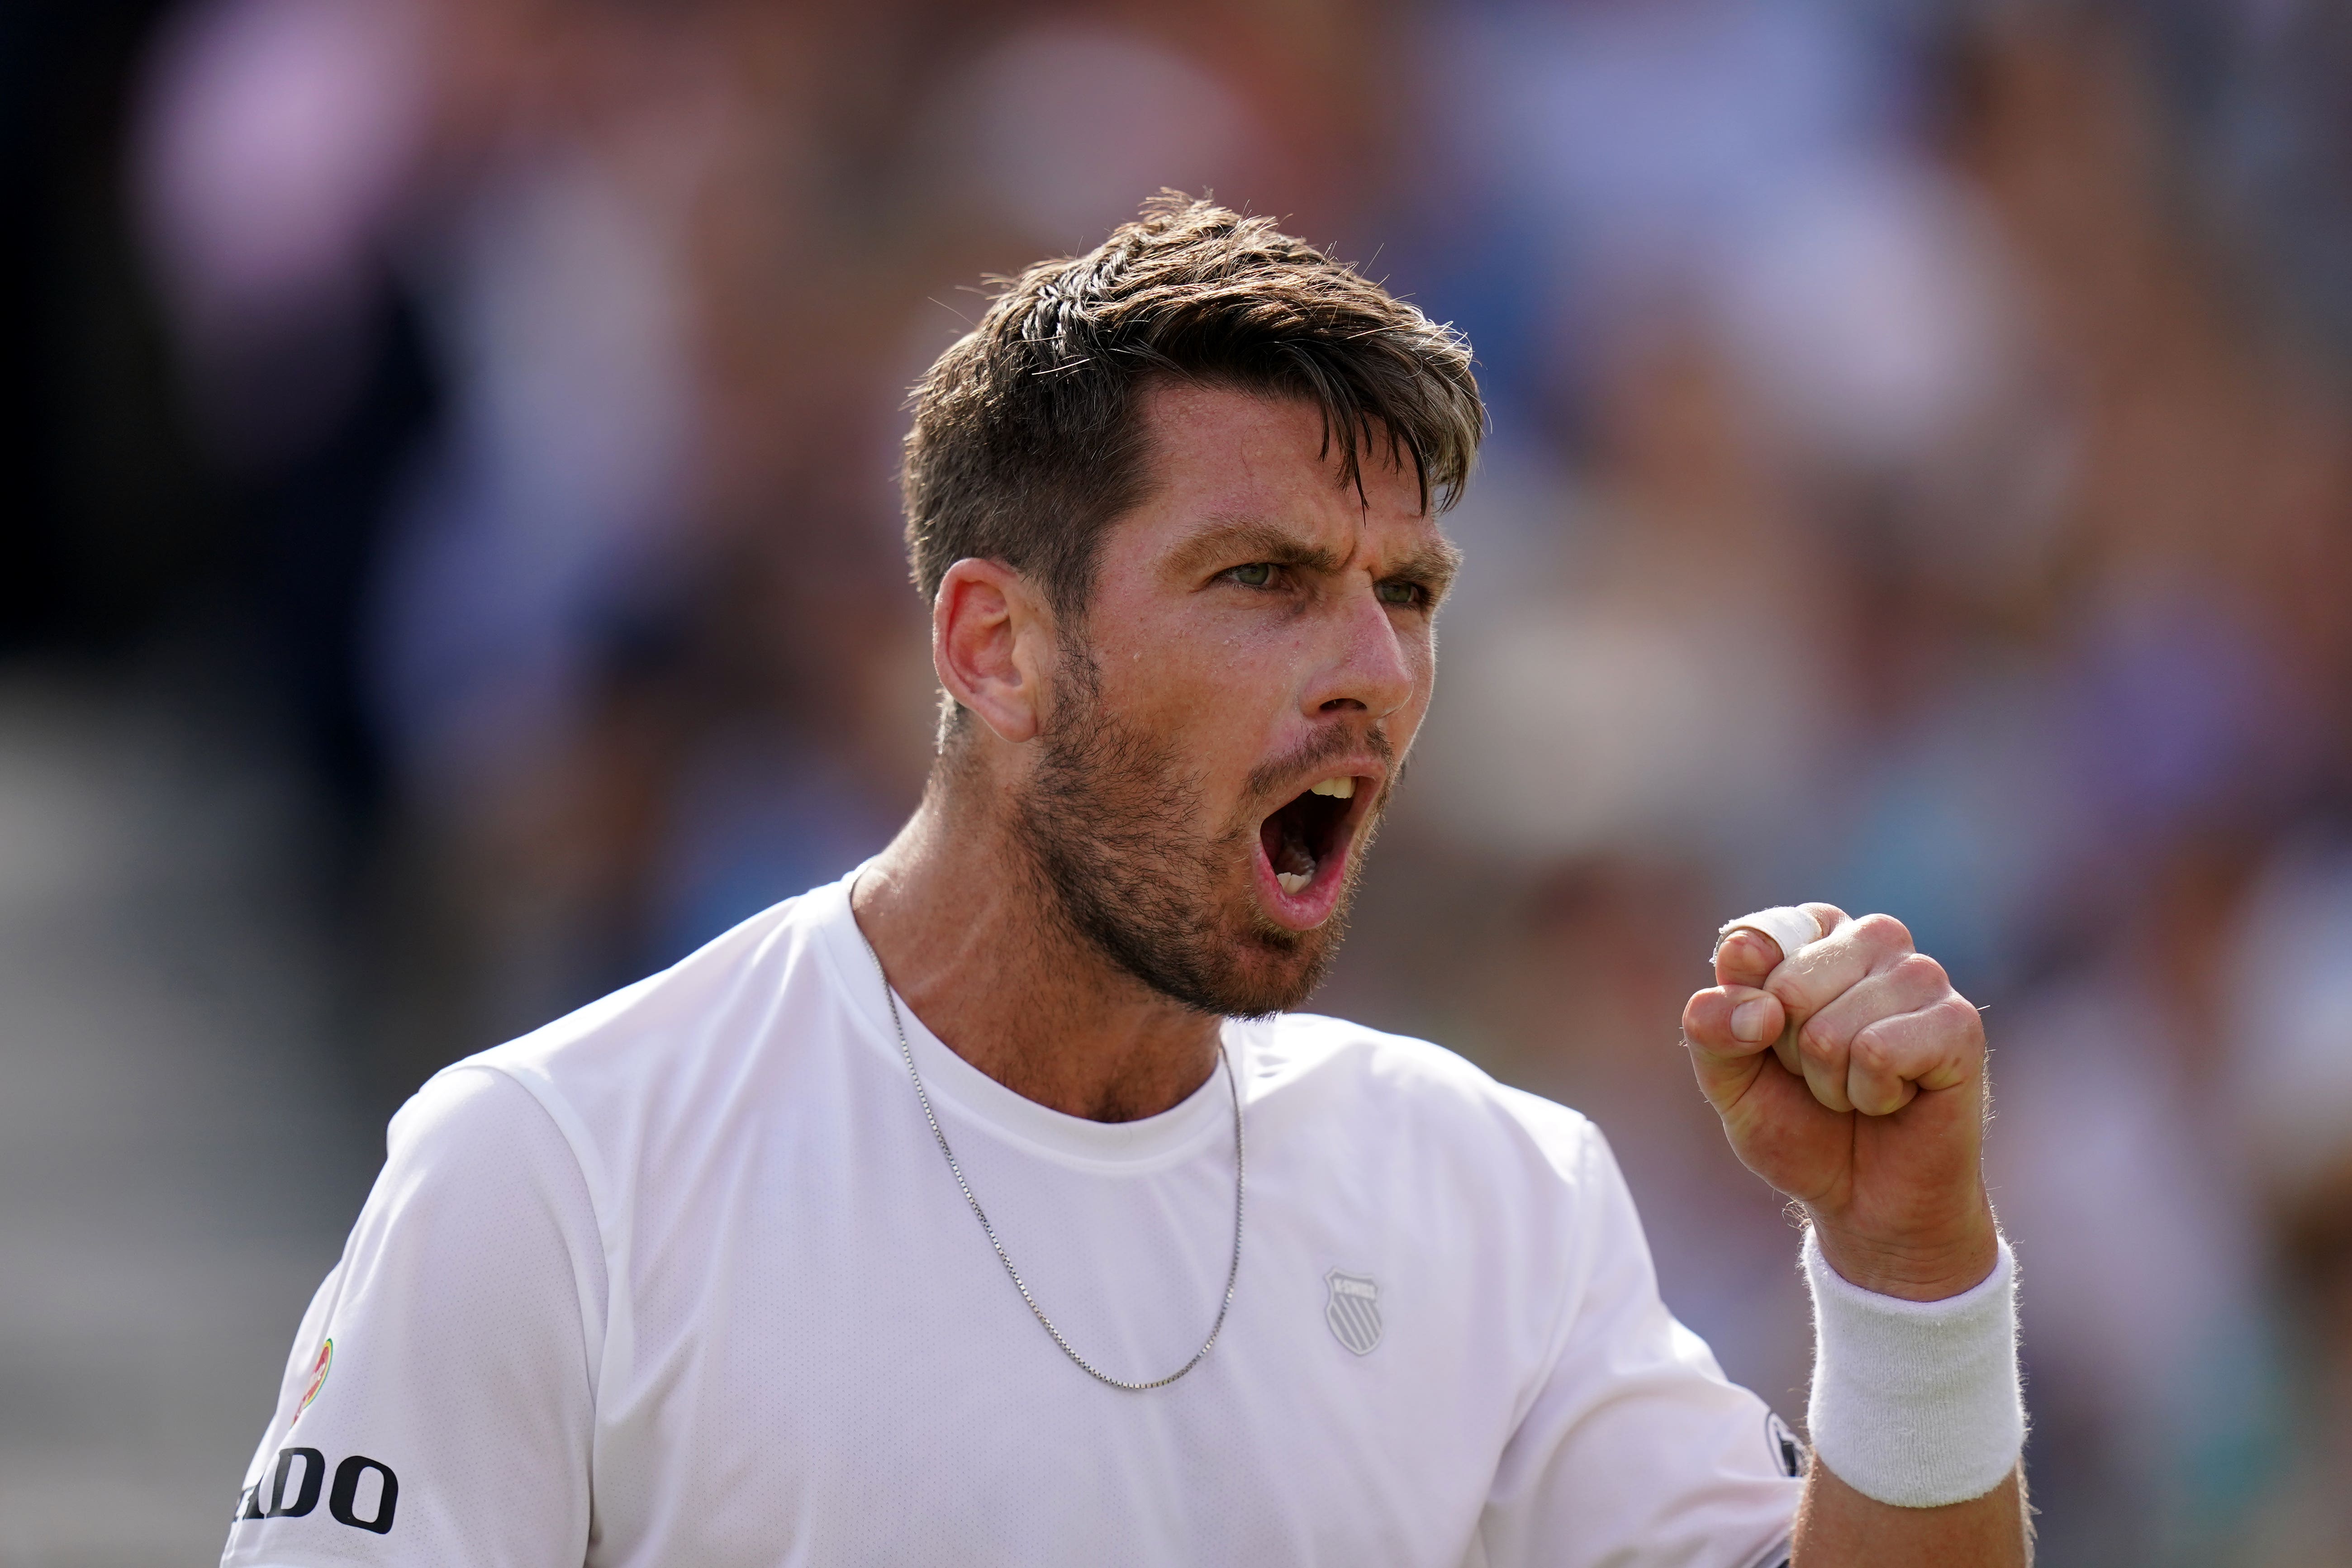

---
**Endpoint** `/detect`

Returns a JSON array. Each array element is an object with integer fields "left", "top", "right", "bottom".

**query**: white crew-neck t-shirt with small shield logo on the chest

[{"left": 221, "top": 884, "right": 1799, "bottom": 1568}]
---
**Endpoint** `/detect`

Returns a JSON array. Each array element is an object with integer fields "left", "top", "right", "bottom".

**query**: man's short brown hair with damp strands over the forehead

[{"left": 903, "top": 190, "right": 1487, "bottom": 616}]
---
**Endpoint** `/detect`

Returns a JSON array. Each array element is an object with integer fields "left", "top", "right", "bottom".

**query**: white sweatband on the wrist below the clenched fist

[{"left": 1804, "top": 1230, "right": 2025, "bottom": 1509}]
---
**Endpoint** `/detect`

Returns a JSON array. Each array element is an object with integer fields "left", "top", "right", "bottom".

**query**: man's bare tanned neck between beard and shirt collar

[{"left": 851, "top": 778, "right": 1218, "bottom": 1121}]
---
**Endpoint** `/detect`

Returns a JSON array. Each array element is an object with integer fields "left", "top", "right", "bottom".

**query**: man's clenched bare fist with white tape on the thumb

[{"left": 1682, "top": 903, "right": 1997, "bottom": 1300}]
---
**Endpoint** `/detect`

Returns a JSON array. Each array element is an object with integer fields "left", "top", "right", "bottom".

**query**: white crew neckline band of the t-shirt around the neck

[{"left": 809, "top": 865, "right": 1249, "bottom": 1175}]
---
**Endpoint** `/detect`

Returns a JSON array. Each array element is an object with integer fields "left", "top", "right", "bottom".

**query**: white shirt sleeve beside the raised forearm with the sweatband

[{"left": 1473, "top": 1128, "right": 1804, "bottom": 1568}]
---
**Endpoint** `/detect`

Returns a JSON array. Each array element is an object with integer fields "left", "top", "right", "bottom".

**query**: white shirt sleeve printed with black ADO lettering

[{"left": 221, "top": 1065, "right": 604, "bottom": 1568}]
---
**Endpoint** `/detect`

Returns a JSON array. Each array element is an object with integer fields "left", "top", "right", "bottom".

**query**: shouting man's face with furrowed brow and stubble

[{"left": 1016, "top": 385, "right": 1454, "bottom": 1016}]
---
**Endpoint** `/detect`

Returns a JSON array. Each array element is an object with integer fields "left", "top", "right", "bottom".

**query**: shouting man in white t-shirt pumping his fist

[{"left": 223, "top": 200, "right": 2025, "bottom": 1568}]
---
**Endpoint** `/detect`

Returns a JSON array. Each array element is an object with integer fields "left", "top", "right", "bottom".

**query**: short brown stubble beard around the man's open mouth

[{"left": 1014, "top": 646, "right": 1378, "bottom": 1018}]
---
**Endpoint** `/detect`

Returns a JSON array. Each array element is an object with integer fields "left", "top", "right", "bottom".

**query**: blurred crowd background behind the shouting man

[{"left": 0, "top": 0, "right": 2352, "bottom": 1568}]
